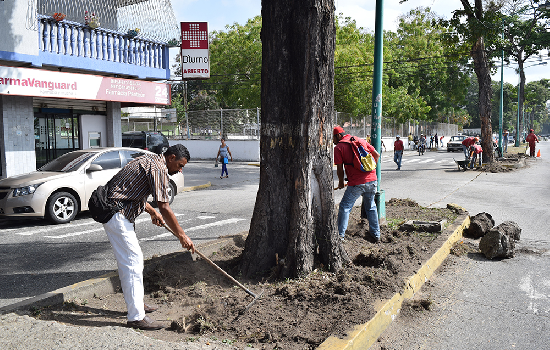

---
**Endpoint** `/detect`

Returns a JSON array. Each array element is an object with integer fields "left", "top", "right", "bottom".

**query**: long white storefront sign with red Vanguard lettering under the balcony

[{"left": 0, "top": 66, "right": 171, "bottom": 105}]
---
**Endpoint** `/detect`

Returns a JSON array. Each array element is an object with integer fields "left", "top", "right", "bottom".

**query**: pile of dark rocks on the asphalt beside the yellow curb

[{"left": 464, "top": 213, "right": 521, "bottom": 259}]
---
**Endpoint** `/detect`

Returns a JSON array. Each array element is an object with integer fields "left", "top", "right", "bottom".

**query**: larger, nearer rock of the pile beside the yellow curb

[{"left": 479, "top": 221, "right": 521, "bottom": 259}]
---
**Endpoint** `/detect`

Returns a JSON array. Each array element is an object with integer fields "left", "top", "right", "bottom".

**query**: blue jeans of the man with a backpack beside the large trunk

[{"left": 338, "top": 181, "right": 380, "bottom": 238}]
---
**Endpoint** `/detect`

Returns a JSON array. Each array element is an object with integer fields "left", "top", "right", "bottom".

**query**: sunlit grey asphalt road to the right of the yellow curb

[{"left": 371, "top": 141, "right": 550, "bottom": 350}]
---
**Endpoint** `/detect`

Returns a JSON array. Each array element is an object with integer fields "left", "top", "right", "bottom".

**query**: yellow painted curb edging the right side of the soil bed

[{"left": 317, "top": 216, "right": 470, "bottom": 350}]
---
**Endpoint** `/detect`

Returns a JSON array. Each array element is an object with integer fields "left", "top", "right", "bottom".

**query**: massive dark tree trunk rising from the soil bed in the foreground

[{"left": 241, "top": 0, "right": 347, "bottom": 277}]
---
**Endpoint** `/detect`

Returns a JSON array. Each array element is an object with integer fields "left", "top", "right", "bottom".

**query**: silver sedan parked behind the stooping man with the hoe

[{"left": 0, "top": 147, "right": 184, "bottom": 224}]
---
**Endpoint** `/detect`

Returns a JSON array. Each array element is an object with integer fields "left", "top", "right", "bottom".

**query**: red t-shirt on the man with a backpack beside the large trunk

[{"left": 334, "top": 135, "right": 376, "bottom": 186}]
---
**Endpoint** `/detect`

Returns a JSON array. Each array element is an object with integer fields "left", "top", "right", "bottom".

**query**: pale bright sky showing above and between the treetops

[{"left": 170, "top": 0, "right": 550, "bottom": 85}]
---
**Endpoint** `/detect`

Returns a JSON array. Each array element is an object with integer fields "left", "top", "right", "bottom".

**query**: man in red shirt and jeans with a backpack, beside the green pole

[{"left": 332, "top": 126, "right": 380, "bottom": 243}]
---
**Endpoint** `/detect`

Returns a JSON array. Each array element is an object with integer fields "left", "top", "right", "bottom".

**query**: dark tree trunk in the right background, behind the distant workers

[{"left": 471, "top": 37, "right": 494, "bottom": 163}]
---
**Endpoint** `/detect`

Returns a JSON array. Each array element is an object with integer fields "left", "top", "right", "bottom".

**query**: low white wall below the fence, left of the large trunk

[{"left": 169, "top": 140, "right": 260, "bottom": 162}]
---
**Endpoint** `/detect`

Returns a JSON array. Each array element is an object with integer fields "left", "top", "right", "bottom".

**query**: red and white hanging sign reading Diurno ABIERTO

[{"left": 181, "top": 22, "right": 210, "bottom": 80}]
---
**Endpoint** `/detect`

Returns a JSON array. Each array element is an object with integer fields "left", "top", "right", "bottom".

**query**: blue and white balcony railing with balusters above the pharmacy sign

[{"left": 38, "top": 17, "right": 168, "bottom": 78}]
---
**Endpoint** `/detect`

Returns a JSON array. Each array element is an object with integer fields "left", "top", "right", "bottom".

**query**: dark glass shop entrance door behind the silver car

[{"left": 34, "top": 110, "right": 80, "bottom": 169}]
